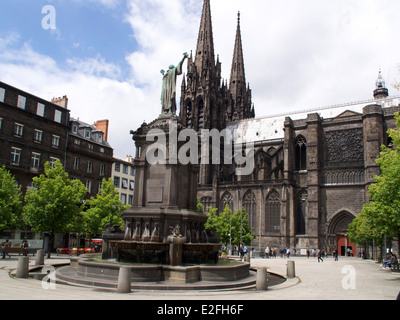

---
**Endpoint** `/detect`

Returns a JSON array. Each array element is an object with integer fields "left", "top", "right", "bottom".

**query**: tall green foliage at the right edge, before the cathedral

[{"left": 349, "top": 113, "right": 400, "bottom": 243}]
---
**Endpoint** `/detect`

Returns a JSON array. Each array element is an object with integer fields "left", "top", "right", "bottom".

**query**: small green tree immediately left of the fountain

[{"left": 83, "top": 178, "right": 130, "bottom": 238}]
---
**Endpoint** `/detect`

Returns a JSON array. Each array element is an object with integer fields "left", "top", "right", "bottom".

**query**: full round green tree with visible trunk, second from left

[{"left": 23, "top": 160, "right": 87, "bottom": 258}]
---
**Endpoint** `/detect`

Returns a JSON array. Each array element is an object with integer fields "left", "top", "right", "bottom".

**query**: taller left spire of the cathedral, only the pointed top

[{"left": 195, "top": 0, "right": 215, "bottom": 70}]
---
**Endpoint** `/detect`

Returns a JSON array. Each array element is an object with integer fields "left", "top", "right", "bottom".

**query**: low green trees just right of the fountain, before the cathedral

[{"left": 205, "top": 205, "right": 256, "bottom": 246}]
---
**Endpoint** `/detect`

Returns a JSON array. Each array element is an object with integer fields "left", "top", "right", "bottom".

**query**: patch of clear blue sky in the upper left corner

[{"left": 0, "top": 0, "right": 137, "bottom": 77}]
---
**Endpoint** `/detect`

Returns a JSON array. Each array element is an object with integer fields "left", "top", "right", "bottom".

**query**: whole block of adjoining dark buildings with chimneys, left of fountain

[{"left": 0, "top": 82, "right": 113, "bottom": 197}]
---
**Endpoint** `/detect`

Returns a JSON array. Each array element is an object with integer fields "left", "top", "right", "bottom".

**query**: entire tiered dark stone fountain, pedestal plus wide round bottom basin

[{"left": 54, "top": 55, "right": 255, "bottom": 289}]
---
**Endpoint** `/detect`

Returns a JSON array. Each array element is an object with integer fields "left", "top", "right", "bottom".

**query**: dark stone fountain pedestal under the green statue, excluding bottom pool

[{"left": 103, "top": 115, "right": 219, "bottom": 266}]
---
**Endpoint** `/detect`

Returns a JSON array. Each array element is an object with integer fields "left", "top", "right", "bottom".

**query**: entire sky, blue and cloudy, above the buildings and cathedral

[{"left": 0, "top": 0, "right": 400, "bottom": 158}]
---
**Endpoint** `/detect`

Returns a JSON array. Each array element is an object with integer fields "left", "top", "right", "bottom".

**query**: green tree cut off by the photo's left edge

[{"left": 0, "top": 166, "right": 22, "bottom": 230}]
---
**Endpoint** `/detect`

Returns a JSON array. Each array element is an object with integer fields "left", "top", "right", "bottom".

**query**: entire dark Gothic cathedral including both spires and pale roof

[{"left": 185, "top": 0, "right": 400, "bottom": 254}]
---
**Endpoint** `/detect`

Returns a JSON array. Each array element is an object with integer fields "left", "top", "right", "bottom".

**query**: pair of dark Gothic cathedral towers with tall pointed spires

[{"left": 180, "top": 0, "right": 254, "bottom": 130}]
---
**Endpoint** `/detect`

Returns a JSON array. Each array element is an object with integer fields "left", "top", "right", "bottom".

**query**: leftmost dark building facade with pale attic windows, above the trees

[{"left": 0, "top": 82, "right": 70, "bottom": 193}]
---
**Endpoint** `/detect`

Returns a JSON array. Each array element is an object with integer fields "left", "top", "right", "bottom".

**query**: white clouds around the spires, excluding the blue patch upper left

[{"left": 0, "top": 0, "right": 400, "bottom": 157}]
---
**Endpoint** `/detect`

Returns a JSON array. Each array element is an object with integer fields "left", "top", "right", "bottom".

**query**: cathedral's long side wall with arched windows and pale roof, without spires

[{"left": 198, "top": 98, "right": 400, "bottom": 252}]
